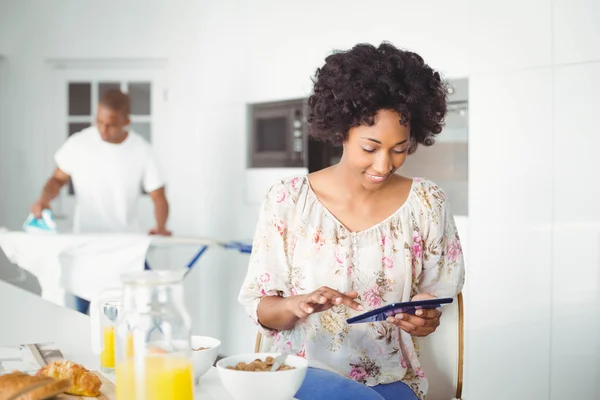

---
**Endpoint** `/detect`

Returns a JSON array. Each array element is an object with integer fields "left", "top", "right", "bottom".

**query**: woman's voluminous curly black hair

[{"left": 307, "top": 42, "right": 448, "bottom": 154}]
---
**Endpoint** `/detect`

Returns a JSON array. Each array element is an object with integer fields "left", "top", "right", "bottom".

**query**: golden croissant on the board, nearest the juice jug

[{"left": 37, "top": 360, "right": 102, "bottom": 397}]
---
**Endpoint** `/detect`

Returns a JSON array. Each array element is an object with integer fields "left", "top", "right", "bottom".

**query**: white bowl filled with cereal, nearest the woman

[{"left": 217, "top": 353, "right": 308, "bottom": 400}]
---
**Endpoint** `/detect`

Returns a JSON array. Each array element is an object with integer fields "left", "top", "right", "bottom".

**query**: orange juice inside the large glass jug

[{"left": 116, "top": 355, "right": 194, "bottom": 400}]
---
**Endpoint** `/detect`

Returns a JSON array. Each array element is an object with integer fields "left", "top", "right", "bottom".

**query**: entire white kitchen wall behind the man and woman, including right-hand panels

[{"left": 0, "top": 0, "right": 600, "bottom": 400}]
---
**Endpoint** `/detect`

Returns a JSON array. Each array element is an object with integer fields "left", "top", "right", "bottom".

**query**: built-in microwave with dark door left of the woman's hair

[{"left": 248, "top": 99, "right": 308, "bottom": 168}]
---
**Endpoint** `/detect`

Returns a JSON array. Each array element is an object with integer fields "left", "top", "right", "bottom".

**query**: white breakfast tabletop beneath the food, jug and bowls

[{"left": 0, "top": 280, "right": 232, "bottom": 400}]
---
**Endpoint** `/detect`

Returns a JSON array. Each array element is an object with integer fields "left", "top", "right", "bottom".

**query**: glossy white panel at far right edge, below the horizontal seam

[{"left": 551, "top": 62, "right": 600, "bottom": 399}]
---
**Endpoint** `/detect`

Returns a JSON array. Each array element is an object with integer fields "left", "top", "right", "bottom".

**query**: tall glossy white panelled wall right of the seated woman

[{"left": 466, "top": 0, "right": 600, "bottom": 400}]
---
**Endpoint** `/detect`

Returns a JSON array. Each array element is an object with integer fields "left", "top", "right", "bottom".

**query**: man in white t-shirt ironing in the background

[{"left": 31, "top": 90, "right": 171, "bottom": 313}]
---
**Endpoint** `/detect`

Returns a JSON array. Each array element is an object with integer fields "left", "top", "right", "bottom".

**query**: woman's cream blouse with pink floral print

[{"left": 239, "top": 177, "right": 464, "bottom": 399}]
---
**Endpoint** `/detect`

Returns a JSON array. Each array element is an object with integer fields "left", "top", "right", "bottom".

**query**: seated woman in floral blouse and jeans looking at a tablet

[{"left": 239, "top": 43, "right": 464, "bottom": 400}]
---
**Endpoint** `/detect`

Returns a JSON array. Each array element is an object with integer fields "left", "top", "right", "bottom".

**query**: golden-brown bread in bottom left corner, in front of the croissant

[{"left": 0, "top": 371, "right": 70, "bottom": 400}]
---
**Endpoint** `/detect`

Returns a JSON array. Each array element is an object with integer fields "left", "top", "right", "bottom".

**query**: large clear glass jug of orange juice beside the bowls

[{"left": 115, "top": 271, "right": 194, "bottom": 400}]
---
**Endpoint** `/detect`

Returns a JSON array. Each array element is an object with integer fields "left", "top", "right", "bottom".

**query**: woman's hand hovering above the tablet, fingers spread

[{"left": 288, "top": 286, "right": 364, "bottom": 319}]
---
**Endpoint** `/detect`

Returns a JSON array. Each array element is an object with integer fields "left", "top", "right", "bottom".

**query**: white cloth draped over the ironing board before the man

[{"left": 0, "top": 228, "right": 152, "bottom": 305}]
